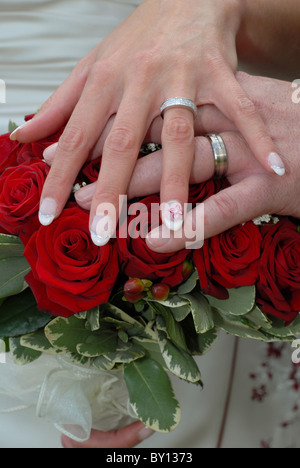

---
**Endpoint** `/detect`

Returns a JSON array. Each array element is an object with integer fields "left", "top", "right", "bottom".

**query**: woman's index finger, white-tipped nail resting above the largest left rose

[{"left": 39, "top": 64, "right": 116, "bottom": 225}]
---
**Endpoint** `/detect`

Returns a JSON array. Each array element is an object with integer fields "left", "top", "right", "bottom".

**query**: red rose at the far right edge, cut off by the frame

[{"left": 257, "top": 218, "right": 300, "bottom": 322}]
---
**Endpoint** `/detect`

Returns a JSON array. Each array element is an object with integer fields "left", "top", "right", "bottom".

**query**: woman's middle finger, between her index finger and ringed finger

[{"left": 90, "top": 90, "right": 151, "bottom": 246}]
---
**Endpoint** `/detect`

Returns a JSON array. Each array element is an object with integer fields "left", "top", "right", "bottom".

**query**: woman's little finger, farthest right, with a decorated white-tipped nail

[{"left": 214, "top": 69, "right": 285, "bottom": 176}]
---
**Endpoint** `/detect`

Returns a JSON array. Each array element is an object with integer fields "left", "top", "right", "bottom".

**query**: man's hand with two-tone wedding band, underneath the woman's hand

[{"left": 76, "top": 73, "right": 300, "bottom": 252}]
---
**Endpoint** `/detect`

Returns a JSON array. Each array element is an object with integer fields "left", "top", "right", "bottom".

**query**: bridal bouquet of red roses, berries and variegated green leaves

[{"left": 0, "top": 117, "right": 300, "bottom": 438}]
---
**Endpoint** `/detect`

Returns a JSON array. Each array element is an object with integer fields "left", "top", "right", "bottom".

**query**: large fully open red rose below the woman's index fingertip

[{"left": 21, "top": 203, "right": 119, "bottom": 317}]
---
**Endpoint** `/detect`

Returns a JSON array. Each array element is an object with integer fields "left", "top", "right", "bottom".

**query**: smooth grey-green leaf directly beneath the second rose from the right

[{"left": 205, "top": 286, "right": 256, "bottom": 315}]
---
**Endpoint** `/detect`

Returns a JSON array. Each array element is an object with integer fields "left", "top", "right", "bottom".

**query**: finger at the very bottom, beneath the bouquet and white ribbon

[{"left": 62, "top": 422, "right": 154, "bottom": 448}]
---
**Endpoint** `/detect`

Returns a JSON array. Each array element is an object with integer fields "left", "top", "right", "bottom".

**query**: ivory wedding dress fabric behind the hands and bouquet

[{"left": 0, "top": 0, "right": 300, "bottom": 449}]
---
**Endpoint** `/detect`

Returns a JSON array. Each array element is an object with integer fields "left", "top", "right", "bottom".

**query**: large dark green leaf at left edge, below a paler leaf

[{"left": 0, "top": 288, "right": 51, "bottom": 337}]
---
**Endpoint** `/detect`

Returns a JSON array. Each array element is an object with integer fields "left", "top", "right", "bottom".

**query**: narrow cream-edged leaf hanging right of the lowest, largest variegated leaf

[{"left": 158, "top": 331, "right": 201, "bottom": 383}]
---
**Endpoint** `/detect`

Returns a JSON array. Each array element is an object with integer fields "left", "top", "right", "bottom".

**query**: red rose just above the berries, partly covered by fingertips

[{"left": 118, "top": 195, "right": 189, "bottom": 287}]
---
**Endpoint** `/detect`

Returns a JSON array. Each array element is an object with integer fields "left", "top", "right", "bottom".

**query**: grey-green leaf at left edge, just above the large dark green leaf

[{"left": 0, "top": 257, "right": 30, "bottom": 298}]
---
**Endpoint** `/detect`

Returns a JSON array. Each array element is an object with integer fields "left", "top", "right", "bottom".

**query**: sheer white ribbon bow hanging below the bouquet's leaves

[{"left": 0, "top": 355, "right": 137, "bottom": 442}]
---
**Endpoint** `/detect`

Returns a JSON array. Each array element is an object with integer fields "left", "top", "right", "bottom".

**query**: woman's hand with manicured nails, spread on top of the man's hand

[{"left": 8, "top": 0, "right": 281, "bottom": 245}]
